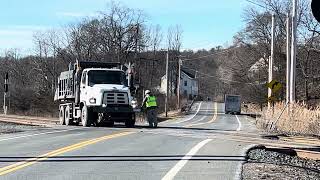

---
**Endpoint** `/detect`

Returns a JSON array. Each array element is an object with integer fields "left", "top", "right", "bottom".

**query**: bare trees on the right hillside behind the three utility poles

[{"left": 212, "top": 0, "right": 320, "bottom": 105}]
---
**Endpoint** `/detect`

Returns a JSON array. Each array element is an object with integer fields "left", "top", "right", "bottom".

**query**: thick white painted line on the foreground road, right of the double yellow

[{"left": 162, "top": 139, "right": 212, "bottom": 180}]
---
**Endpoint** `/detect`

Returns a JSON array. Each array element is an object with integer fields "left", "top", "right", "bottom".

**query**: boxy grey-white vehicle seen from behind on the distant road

[{"left": 224, "top": 95, "right": 241, "bottom": 114}]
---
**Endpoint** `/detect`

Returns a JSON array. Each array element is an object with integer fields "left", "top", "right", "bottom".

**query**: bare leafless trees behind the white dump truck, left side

[{"left": 0, "top": 2, "right": 219, "bottom": 115}]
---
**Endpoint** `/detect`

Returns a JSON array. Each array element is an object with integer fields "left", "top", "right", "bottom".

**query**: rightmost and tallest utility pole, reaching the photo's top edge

[{"left": 290, "top": 0, "right": 297, "bottom": 103}]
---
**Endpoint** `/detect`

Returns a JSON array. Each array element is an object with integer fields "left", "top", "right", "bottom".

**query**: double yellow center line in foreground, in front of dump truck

[{"left": 0, "top": 132, "right": 135, "bottom": 176}]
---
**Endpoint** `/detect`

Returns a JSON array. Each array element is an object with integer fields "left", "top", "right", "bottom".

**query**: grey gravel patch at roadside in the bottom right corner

[{"left": 242, "top": 148, "right": 320, "bottom": 180}]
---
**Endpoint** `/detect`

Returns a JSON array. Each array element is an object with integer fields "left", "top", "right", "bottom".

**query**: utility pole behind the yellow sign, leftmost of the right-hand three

[{"left": 268, "top": 14, "right": 276, "bottom": 109}]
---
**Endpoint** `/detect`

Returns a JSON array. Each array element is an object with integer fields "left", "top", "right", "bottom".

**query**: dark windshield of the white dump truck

[{"left": 88, "top": 70, "right": 127, "bottom": 86}]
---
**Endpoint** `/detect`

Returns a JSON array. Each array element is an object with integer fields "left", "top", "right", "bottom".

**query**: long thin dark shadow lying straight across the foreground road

[{"left": 0, "top": 155, "right": 246, "bottom": 162}]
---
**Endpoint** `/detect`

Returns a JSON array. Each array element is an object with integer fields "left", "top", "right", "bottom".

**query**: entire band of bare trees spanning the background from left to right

[{"left": 0, "top": 0, "right": 320, "bottom": 115}]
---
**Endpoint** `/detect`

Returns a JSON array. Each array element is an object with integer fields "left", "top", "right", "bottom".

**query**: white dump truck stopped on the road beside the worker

[{"left": 54, "top": 61, "right": 136, "bottom": 127}]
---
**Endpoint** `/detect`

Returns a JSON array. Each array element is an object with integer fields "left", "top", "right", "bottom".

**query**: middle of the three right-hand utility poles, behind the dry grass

[{"left": 286, "top": 13, "right": 291, "bottom": 103}]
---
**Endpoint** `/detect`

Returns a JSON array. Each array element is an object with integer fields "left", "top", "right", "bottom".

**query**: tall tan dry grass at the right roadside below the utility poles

[{"left": 257, "top": 103, "right": 320, "bottom": 136}]
